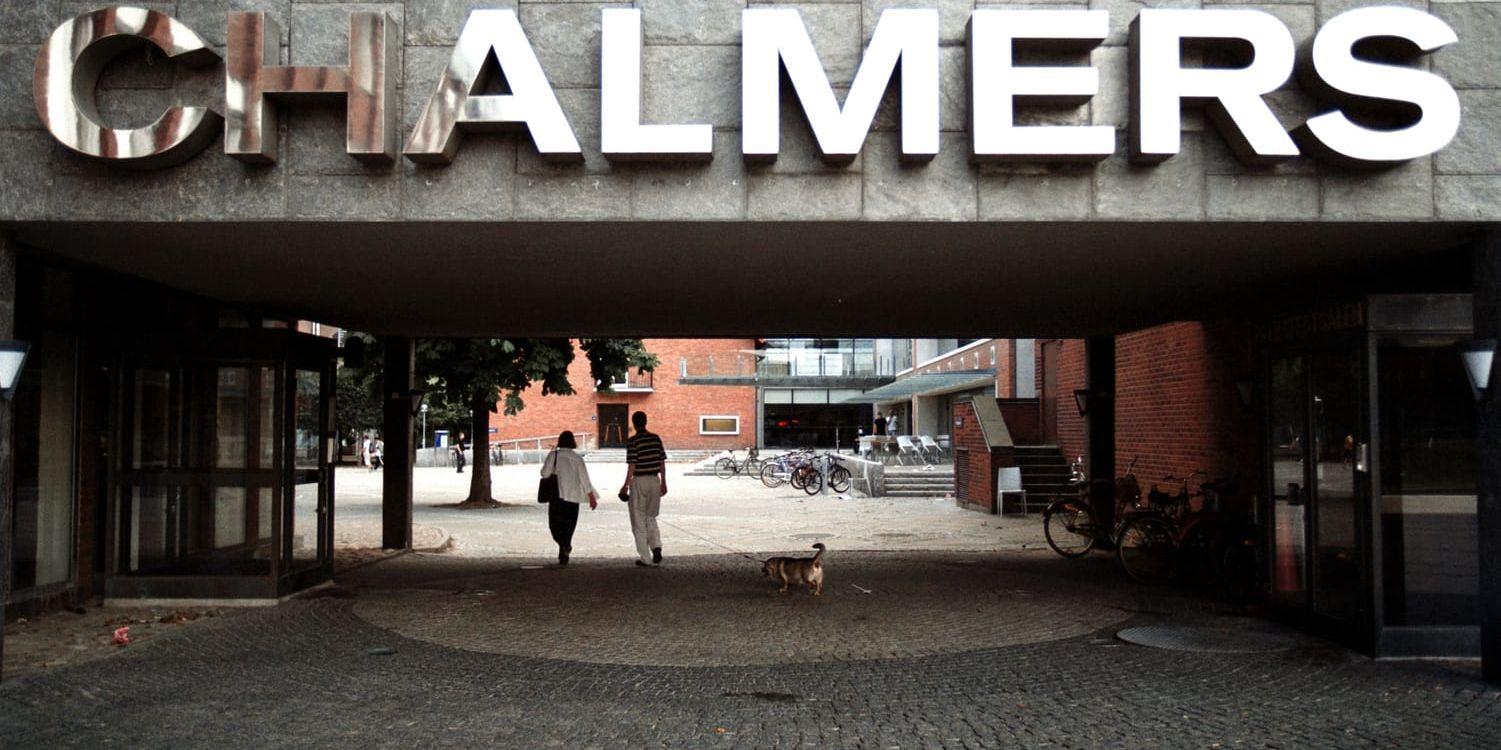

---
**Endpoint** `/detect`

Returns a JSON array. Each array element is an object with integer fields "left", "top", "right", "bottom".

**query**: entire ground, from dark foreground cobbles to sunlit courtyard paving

[{"left": 0, "top": 467, "right": 1501, "bottom": 749}]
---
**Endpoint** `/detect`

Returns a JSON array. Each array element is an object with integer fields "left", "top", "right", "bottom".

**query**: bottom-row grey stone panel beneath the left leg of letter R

[{"left": 1094, "top": 135, "right": 1204, "bottom": 221}]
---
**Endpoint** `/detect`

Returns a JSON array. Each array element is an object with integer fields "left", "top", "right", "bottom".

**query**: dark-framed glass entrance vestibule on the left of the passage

[{"left": 107, "top": 343, "right": 333, "bottom": 599}]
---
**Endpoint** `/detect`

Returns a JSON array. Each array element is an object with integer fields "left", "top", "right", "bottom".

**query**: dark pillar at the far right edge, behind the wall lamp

[{"left": 1474, "top": 228, "right": 1501, "bottom": 686}]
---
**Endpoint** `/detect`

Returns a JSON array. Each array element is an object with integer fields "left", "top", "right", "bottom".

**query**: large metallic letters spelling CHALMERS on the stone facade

[{"left": 33, "top": 6, "right": 1459, "bottom": 168}]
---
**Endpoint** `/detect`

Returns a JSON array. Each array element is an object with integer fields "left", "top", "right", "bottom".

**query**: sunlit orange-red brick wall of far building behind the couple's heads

[{"left": 489, "top": 339, "right": 757, "bottom": 450}]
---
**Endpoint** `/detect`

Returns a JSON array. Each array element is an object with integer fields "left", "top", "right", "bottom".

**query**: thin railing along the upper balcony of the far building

[{"left": 677, "top": 350, "right": 899, "bottom": 380}]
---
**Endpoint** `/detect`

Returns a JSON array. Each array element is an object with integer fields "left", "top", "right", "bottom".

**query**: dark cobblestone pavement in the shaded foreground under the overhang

[{"left": 0, "top": 552, "right": 1501, "bottom": 749}]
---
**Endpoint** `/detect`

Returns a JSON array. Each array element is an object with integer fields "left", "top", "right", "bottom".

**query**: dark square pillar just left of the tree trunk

[{"left": 381, "top": 336, "right": 416, "bottom": 549}]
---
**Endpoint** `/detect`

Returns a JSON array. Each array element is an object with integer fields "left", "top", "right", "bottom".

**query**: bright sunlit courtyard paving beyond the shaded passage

[{"left": 335, "top": 464, "right": 1046, "bottom": 561}]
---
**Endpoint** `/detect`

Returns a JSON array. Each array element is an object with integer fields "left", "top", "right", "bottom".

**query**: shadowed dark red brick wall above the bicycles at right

[{"left": 1115, "top": 321, "right": 1259, "bottom": 486}]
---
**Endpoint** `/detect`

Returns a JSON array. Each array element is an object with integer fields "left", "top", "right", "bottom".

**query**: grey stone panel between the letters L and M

[{"left": 642, "top": 45, "right": 740, "bottom": 129}]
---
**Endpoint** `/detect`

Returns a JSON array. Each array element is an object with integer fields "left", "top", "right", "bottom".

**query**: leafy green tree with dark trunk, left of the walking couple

[{"left": 417, "top": 339, "right": 657, "bottom": 509}]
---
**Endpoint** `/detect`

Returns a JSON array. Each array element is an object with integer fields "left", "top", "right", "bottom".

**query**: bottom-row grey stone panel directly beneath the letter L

[{"left": 630, "top": 134, "right": 746, "bottom": 221}]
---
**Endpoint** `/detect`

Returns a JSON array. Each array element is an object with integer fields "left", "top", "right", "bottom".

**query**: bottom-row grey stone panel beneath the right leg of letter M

[{"left": 865, "top": 134, "right": 979, "bottom": 222}]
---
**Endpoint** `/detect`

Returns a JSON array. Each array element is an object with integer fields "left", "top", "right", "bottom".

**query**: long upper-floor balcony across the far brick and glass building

[{"left": 677, "top": 350, "right": 896, "bottom": 389}]
